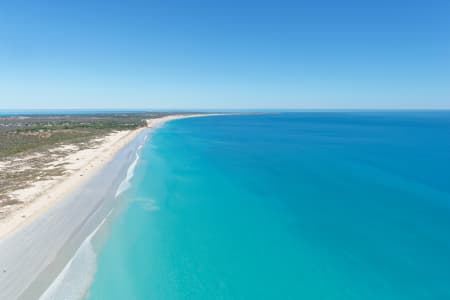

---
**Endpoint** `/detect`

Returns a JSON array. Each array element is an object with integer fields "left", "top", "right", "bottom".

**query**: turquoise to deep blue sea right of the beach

[{"left": 87, "top": 112, "right": 450, "bottom": 300}]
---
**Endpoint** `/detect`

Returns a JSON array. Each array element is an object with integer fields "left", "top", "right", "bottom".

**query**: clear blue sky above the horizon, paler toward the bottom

[{"left": 0, "top": 0, "right": 450, "bottom": 109}]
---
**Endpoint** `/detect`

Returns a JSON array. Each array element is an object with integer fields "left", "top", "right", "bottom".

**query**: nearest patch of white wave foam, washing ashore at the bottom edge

[{"left": 39, "top": 212, "right": 111, "bottom": 300}]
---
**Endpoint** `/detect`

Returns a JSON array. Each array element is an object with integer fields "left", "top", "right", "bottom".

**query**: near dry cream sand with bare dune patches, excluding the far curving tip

[{"left": 0, "top": 129, "right": 142, "bottom": 237}]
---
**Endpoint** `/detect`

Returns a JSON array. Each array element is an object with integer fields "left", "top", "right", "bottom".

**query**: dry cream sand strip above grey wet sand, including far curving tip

[{"left": 0, "top": 115, "right": 199, "bottom": 239}]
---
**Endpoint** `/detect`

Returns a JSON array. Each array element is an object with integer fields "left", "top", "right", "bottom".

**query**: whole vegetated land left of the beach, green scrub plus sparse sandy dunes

[{"left": 0, "top": 112, "right": 171, "bottom": 213}]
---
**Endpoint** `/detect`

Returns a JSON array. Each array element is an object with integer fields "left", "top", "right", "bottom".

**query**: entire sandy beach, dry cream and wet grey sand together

[{"left": 0, "top": 114, "right": 204, "bottom": 299}]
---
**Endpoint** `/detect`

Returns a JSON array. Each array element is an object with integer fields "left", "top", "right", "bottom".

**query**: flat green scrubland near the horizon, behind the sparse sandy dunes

[{"left": 0, "top": 113, "right": 168, "bottom": 160}]
